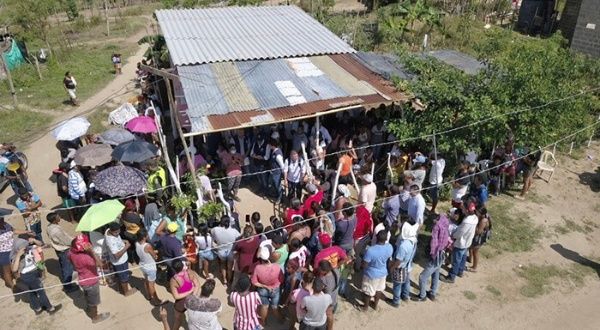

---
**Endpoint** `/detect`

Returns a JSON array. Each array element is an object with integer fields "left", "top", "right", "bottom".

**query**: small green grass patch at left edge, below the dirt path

[{"left": 0, "top": 109, "right": 51, "bottom": 146}]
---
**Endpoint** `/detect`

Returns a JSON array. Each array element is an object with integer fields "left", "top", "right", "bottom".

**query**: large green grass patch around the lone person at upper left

[{"left": 0, "top": 44, "right": 135, "bottom": 110}]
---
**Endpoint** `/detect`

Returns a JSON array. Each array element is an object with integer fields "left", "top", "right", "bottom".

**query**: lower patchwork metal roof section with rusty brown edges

[{"left": 175, "top": 54, "right": 406, "bottom": 135}]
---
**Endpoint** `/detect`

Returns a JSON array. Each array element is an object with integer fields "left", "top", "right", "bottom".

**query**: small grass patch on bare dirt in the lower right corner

[{"left": 516, "top": 265, "right": 562, "bottom": 298}]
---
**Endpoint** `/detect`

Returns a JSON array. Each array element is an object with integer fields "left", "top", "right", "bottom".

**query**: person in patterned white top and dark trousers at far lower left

[{"left": 12, "top": 239, "right": 62, "bottom": 315}]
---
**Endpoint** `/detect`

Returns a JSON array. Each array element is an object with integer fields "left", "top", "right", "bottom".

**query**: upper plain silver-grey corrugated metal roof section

[{"left": 156, "top": 6, "right": 355, "bottom": 66}]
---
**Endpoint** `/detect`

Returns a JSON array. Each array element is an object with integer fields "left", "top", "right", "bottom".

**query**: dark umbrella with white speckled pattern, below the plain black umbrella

[{"left": 94, "top": 165, "right": 146, "bottom": 197}]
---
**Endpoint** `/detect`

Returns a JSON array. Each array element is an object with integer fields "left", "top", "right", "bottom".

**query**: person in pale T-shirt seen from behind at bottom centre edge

[{"left": 300, "top": 278, "right": 333, "bottom": 330}]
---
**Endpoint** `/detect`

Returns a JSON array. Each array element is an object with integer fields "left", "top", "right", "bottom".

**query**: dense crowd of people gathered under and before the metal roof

[{"left": 0, "top": 112, "right": 536, "bottom": 330}]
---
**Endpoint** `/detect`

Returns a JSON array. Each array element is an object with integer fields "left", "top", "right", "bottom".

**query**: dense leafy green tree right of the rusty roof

[{"left": 389, "top": 31, "right": 600, "bottom": 153}]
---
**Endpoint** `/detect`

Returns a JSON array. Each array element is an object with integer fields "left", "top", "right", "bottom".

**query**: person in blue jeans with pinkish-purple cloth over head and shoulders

[{"left": 412, "top": 214, "right": 450, "bottom": 301}]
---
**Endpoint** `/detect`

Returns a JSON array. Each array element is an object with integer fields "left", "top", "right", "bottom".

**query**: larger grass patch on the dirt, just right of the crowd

[{"left": 482, "top": 201, "right": 544, "bottom": 255}]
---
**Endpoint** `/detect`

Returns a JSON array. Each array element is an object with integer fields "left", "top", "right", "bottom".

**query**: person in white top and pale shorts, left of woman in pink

[{"left": 135, "top": 228, "right": 162, "bottom": 306}]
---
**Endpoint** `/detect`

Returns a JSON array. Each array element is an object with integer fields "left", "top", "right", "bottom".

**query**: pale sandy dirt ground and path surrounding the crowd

[{"left": 0, "top": 23, "right": 600, "bottom": 329}]
